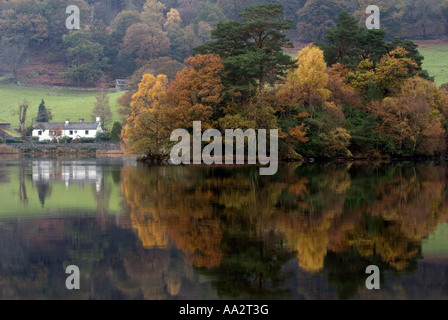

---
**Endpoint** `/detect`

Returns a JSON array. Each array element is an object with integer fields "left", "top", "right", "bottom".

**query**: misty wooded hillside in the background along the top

[{"left": 0, "top": 0, "right": 448, "bottom": 87}]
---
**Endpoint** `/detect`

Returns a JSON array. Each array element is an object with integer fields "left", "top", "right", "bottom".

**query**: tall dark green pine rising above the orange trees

[{"left": 194, "top": 4, "right": 294, "bottom": 97}]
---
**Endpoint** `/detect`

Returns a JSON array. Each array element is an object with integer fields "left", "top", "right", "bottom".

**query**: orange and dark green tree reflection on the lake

[{"left": 122, "top": 163, "right": 448, "bottom": 298}]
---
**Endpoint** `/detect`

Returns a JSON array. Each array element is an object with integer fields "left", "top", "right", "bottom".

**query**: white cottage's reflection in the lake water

[{"left": 32, "top": 160, "right": 103, "bottom": 192}]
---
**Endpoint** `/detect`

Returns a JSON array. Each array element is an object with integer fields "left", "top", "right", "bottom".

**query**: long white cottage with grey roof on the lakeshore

[{"left": 33, "top": 117, "right": 103, "bottom": 141}]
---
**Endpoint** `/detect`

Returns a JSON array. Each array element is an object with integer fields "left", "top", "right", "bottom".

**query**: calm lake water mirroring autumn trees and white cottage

[{"left": 0, "top": 157, "right": 448, "bottom": 300}]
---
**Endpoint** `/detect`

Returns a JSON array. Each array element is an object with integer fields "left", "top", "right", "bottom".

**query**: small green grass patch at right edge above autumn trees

[{"left": 419, "top": 45, "right": 448, "bottom": 86}]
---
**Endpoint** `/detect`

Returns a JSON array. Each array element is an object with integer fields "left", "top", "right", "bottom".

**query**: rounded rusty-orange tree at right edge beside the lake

[{"left": 370, "top": 77, "right": 448, "bottom": 156}]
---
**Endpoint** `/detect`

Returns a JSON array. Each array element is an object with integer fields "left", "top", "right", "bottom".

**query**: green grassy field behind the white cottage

[{"left": 0, "top": 78, "right": 122, "bottom": 128}]
